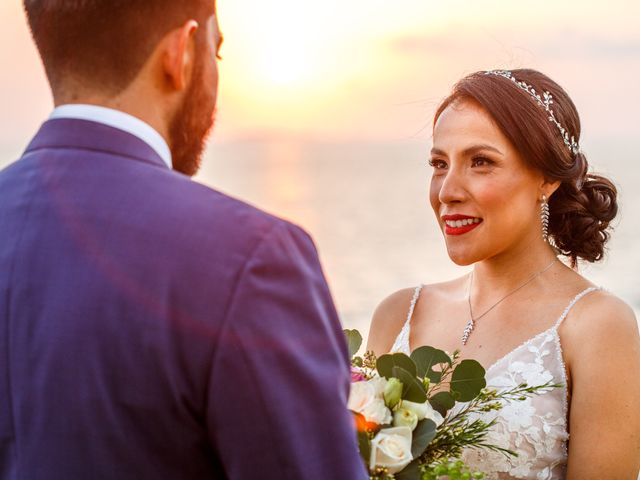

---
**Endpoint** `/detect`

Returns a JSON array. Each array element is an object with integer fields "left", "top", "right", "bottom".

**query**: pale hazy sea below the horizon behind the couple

[{"left": 197, "top": 140, "right": 640, "bottom": 334}]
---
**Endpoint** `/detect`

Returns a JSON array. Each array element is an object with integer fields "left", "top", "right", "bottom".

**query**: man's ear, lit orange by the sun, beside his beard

[{"left": 162, "top": 20, "right": 199, "bottom": 91}]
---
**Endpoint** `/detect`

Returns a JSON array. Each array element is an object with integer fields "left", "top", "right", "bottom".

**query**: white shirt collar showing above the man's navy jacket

[{"left": 49, "top": 104, "right": 173, "bottom": 168}]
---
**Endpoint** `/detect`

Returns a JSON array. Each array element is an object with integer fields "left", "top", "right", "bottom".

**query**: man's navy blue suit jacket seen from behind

[{"left": 0, "top": 119, "right": 366, "bottom": 480}]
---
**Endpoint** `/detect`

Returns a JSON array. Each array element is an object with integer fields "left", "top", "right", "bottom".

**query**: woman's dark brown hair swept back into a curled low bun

[{"left": 434, "top": 69, "right": 618, "bottom": 266}]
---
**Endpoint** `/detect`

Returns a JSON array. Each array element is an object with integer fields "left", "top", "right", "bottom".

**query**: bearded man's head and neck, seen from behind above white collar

[{"left": 24, "top": 0, "right": 221, "bottom": 175}]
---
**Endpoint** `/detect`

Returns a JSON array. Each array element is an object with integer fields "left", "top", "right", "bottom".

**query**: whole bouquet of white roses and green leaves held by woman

[{"left": 345, "top": 330, "right": 557, "bottom": 480}]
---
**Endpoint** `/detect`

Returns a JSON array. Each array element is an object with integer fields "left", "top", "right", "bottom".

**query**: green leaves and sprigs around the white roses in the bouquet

[{"left": 345, "top": 330, "right": 560, "bottom": 480}]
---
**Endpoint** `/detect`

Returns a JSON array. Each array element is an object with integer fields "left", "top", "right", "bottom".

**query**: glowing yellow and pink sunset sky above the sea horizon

[{"left": 0, "top": 0, "right": 640, "bottom": 157}]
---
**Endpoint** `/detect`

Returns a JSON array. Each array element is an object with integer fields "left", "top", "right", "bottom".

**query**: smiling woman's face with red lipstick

[{"left": 430, "top": 100, "right": 544, "bottom": 265}]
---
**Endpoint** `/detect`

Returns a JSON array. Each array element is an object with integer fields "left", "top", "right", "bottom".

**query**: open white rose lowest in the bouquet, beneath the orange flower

[{"left": 369, "top": 427, "right": 413, "bottom": 474}]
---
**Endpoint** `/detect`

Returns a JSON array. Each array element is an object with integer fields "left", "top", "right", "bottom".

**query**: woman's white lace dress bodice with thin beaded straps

[{"left": 391, "top": 287, "right": 597, "bottom": 480}]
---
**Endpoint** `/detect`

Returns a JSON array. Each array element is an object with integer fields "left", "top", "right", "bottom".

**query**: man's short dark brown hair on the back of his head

[{"left": 24, "top": 0, "right": 215, "bottom": 94}]
